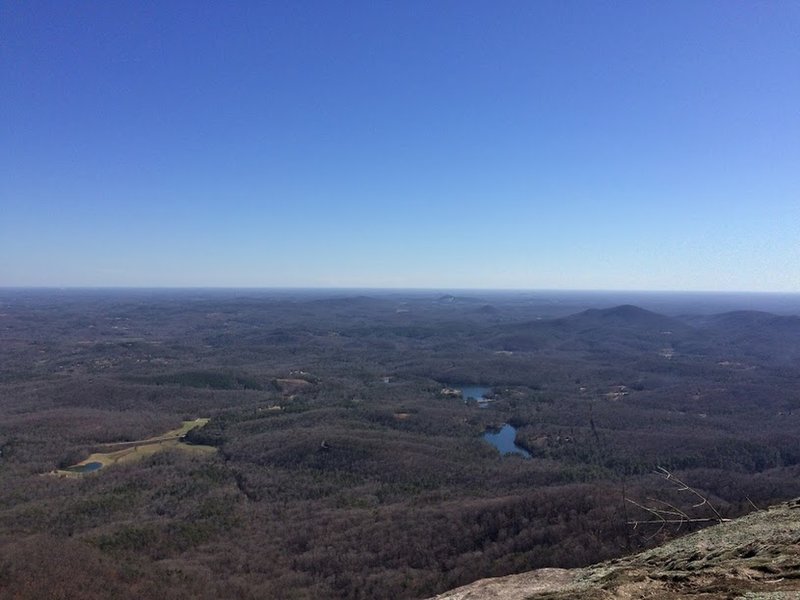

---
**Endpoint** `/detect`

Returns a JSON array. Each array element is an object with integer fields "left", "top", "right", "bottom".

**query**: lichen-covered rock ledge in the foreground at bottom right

[{"left": 435, "top": 499, "right": 800, "bottom": 600}]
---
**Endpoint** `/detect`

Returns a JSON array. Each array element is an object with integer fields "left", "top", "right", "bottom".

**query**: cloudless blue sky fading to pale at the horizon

[{"left": 0, "top": 0, "right": 800, "bottom": 292}]
